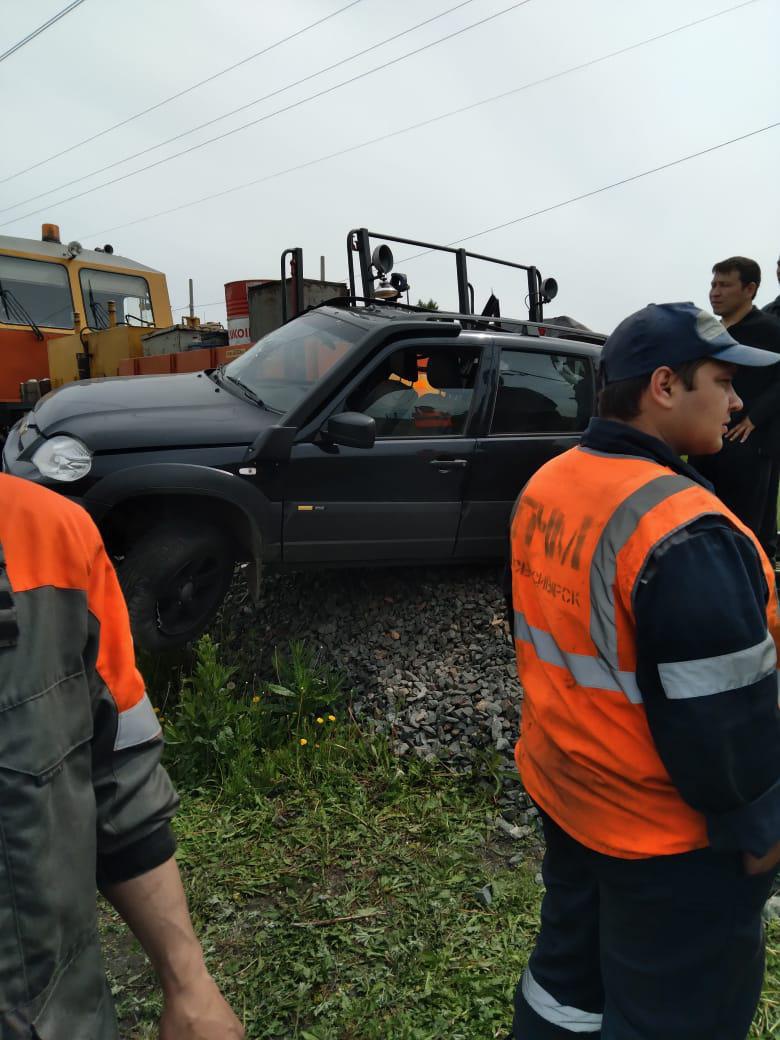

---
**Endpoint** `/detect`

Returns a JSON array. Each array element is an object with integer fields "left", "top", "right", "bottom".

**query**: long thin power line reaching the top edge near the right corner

[{"left": 76, "top": 0, "right": 757, "bottom": 238}]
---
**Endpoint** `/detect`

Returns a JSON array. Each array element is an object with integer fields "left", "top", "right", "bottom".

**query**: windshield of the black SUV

[{"left": 225, "top": 312, "right": 365, "bottom": 413}]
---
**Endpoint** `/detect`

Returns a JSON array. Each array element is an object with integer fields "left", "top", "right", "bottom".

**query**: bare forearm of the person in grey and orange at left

[{"left": 103, "top": 857, "right": 207, "bottom": 994}]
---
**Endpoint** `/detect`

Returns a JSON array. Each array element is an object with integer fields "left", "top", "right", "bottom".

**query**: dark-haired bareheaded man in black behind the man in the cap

[{"left": 691, "top": 257, "right": 780, "bottom": 561}]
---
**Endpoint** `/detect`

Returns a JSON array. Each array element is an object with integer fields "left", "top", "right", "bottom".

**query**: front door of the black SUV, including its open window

[{"left": 282, "top": 339, "right": 484, "bottom": 564}]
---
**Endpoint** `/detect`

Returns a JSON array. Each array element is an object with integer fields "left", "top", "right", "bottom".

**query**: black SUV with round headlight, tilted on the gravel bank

[{"left": 3, "top": 231, "right": 601, "bottom": 650}]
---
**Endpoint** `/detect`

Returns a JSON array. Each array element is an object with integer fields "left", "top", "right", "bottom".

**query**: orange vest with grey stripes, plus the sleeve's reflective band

[{"left": 512, "top": 448, "right": 777, "bottom": 858}]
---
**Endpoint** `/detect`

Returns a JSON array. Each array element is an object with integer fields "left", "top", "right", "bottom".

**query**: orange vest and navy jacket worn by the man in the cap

[{"left": 512, "top": 420, "right": 780, "bottom": 859}]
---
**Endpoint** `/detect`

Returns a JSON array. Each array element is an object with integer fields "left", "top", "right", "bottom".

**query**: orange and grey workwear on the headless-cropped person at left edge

[{"left": 0, "top": 474, "right": 177, "bottom": 1040}]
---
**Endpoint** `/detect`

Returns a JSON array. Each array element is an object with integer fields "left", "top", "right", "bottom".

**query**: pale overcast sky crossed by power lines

[{"left": 0, "top": 0, "right": 780, "bottom": 332}]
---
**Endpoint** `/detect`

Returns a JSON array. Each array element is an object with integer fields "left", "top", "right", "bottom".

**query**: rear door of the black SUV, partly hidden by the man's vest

[{"left": 456, "top": 340, "right": 595, "bottom": 558}]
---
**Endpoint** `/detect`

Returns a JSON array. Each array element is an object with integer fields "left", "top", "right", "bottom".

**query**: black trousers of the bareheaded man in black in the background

[{"left": 690, "top": 441, "right": 778, "bottom": 564}]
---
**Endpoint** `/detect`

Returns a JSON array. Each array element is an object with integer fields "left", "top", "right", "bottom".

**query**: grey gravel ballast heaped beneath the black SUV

[{"left": 220, "top": 566, "right": 522, "bottom": 768}]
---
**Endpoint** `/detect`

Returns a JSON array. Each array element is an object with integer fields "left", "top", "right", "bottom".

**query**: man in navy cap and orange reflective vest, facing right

[{"left": 512, "top": 304, "right": 780, "bottom": 1040}]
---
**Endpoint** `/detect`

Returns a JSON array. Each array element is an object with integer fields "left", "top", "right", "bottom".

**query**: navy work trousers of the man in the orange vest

[{"left": 513, "top": 814, "right": 774, "bottom": 1040}]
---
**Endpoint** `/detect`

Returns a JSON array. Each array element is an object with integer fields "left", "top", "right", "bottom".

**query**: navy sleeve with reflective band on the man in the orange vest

[{"left": 634, "top": 517, "right": 780, "bottom": 855}]
